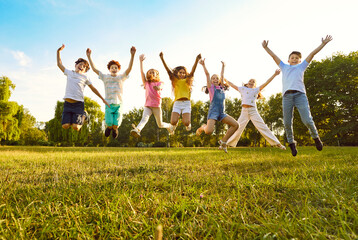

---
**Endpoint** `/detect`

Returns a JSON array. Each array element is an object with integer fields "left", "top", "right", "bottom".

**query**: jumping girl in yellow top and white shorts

[{"left": 159, "top": 52, "right": 201, "bottom": 135}]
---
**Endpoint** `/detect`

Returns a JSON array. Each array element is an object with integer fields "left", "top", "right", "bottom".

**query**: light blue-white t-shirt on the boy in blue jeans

[{"left": 278, "top": 60, "right": 309, "bottom": 94}]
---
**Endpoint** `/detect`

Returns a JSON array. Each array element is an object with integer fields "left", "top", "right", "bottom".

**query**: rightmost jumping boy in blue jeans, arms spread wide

[{"left": 262, "top": 35, "right": 332, "bottom": 156}]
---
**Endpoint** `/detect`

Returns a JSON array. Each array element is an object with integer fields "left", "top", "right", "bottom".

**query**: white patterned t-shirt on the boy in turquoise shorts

[{"left": 98, "top": 71, "right": 129, "bottom": 104}]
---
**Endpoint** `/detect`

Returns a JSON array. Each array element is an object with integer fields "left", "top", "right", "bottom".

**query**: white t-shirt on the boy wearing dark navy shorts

[{"left": 63, "top": 69, "right": 92, "bottom": 102}]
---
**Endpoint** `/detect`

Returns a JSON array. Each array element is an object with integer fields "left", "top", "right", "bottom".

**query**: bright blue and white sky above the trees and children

[{"left": 0, "top": 0, "right": 358, "bottom": 121}]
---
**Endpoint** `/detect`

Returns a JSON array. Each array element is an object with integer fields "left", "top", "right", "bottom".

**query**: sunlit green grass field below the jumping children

[{"left": 0, "top": 147, "right": 358, "bottom": 239}]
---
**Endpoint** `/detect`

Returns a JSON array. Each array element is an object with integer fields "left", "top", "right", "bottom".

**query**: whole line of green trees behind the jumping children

[{"left": 0, "top": 52, "right": 358, "bottom": 147}]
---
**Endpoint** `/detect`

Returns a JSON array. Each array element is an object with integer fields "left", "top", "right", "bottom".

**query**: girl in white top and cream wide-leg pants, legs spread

[{"left": 227, "top": 69, "right": 286, "bottom": 150}]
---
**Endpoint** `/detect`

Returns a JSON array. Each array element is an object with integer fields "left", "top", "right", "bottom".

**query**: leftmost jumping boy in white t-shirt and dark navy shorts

[{"left": 57, "top": 44, "right": 108, "bottom": 131}]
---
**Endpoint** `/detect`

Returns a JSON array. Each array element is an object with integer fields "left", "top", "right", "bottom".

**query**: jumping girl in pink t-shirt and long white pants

[{"left": 131, "top": 54, "right": 173, "bottom": 138}]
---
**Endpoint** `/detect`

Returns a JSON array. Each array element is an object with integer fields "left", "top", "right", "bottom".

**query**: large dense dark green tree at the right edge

[{"left": 305, "top": 52, "right": 358, "bottom": 145}]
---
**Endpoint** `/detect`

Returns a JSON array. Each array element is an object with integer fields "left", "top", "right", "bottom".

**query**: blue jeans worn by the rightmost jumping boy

[{"left": 282, "top": 92, "right": 318, "bottom": 143}]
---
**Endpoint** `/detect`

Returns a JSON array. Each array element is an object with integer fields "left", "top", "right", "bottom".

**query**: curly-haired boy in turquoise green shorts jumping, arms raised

[{"left": 86, "top": 47, "right": 136, "bottom": 138}]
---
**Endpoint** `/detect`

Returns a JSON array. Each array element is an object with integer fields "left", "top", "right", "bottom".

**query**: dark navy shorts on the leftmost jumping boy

[{"left": 62, "top": 101, "right": 85, "bottom": 125}]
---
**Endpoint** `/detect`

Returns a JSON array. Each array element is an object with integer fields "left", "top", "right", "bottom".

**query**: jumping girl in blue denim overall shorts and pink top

[{"left": 196, "top": 59, "right": 239, "bottom": 153}]
